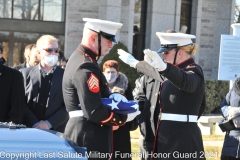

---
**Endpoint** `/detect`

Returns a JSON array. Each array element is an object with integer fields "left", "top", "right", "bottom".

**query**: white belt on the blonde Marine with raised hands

[{"left": 159, "top": 113, "right": 198, "bottom": 122}]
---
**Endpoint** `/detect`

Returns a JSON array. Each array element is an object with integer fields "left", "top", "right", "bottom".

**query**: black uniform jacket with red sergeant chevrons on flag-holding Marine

[{"left": 63, "top": 45, "right": 127, "bottom": 156}]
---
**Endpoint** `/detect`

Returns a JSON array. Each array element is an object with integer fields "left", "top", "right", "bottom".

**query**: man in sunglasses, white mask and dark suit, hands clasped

[{"left": 20, "top": 35, "right": 69, "bottom": 132}]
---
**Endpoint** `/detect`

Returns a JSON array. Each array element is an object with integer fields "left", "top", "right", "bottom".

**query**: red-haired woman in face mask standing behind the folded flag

[{"left": 103, "top": 60, "right": 137, "bottom": 159}]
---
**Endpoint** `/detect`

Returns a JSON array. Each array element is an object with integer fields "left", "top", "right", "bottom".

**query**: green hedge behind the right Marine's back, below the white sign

[{"left": 204, "top": 80, "right": 229, "bottom": 114}]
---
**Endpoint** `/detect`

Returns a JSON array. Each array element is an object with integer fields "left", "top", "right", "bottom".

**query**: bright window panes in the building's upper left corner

[{"left": 0, "top": 0, "right": 65, "bottom": 22}]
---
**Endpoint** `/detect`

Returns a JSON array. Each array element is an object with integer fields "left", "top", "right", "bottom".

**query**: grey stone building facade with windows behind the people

[{"left": 0, "top": 0, "right": 236, "bottom": 79}]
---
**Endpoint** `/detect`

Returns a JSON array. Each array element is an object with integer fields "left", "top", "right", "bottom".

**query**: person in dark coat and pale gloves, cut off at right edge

[{"left": 220, "top": 78, "right": 240, "bottom": 160}]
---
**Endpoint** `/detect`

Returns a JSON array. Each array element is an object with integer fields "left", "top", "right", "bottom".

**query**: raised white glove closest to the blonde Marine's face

[{"left": 143, "top": 49, "right": 167, "bottom": 71}]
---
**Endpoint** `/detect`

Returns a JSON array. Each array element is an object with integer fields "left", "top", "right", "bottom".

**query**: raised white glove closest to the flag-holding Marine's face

[{"left": 118, "top": 49, "right": 139, "bottom": 68}]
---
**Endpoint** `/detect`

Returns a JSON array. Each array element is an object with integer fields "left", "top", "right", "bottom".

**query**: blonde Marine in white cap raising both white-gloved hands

[{"left": 118, "top": 32, "right": 206, "bottom": 159}]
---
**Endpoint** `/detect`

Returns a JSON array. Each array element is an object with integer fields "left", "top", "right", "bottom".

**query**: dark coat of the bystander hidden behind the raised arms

[{"left": 134, "top": 75, "right": 160, "bottom": 143}]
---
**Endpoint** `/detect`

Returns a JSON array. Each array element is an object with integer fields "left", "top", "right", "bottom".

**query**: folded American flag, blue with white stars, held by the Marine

[{"left": 78, "top": 98, "right": 139, "bottom": 114}]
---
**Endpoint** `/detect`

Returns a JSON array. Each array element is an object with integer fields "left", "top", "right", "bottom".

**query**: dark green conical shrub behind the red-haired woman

[{"left": 100, "top": 42, "right": 139, "bottom": 89}]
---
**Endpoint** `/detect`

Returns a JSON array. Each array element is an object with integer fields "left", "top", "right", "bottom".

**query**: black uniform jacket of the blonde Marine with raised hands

[{"left": 137, "top": 58, "right": 205, "bottom": 159}]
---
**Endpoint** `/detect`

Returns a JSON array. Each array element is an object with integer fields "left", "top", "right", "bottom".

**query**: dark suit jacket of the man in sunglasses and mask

[{"left": 20, "top": 65, "right": 69, "bottom": 132}]
